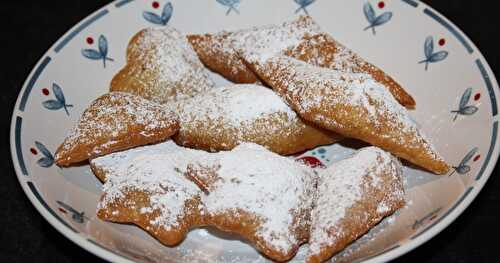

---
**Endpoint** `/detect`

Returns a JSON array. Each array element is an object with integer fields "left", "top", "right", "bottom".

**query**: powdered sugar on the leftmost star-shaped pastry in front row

[{"left": 92, "top": 141, "right": 206, "bottom": 230}]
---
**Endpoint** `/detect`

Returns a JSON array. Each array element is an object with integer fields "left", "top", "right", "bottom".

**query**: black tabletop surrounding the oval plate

[{"left": 0, "top": 0, "right": 500, "bottom": 262}]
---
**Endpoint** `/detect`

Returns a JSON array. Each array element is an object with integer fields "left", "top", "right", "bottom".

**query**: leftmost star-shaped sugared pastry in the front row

[{"left": 91, "top": 141, "right": 208, "bottom": 246}]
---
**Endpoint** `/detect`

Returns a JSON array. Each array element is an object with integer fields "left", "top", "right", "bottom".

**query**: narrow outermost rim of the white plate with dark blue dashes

[{"left": 10, "top": 0, "right": 500, "bottom": 263}]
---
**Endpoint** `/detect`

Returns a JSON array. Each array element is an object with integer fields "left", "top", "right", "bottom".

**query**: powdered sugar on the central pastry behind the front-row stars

[{"left": 175, "top": 85, "right": 305, "bottom": 146}]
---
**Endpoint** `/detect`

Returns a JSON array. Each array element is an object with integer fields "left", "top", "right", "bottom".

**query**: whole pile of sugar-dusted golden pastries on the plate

[{"left": 56, "top": 17, "right": 449, "bottom": 262}]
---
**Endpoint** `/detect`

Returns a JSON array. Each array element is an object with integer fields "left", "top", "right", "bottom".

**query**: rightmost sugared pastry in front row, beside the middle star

[{"left": 307, "top": 147, "right": 405, "bottom": 263}]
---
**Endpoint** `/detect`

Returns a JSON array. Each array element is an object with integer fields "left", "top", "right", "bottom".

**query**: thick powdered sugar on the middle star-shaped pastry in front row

[{"left": 194, "top": 143, "right": 315, "bottom": 255}]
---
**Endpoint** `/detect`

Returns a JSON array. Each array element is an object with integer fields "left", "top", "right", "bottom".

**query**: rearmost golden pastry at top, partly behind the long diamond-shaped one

[{"left": 188, "top": 16, "right": 415, "bottom": 108}]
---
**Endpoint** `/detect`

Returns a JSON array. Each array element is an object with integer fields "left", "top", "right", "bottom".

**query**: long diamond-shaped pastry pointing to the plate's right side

[{"left": 242, "top": 55, "right": 449, "bottom": 174}]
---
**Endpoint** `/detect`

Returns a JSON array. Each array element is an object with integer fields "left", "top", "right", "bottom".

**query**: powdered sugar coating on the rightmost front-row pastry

[{"left": 309, "top": 147, "right": 404, "bottom": 254}]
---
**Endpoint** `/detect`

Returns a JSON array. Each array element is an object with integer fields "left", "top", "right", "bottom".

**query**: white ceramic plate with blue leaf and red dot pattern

[{"left": 11, "top": 0, "right": 499, "bottom": 262}]
